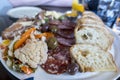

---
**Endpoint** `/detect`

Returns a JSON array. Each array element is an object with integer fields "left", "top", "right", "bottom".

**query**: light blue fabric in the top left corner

[{"left": 0, "top": 0, "right": 12, "bottom": 15}]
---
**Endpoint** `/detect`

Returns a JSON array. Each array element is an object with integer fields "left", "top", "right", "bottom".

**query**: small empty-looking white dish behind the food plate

[{"left": 7, "top": 7, "right": 42, "bottom": 18}]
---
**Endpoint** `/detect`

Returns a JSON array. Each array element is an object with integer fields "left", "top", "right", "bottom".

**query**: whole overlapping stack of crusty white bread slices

[{"left": 70, "top": 11, "right": 117, "bottom": 72}]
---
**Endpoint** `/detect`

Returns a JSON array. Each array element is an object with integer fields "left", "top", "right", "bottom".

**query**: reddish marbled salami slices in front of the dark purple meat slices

[{"left": 42, "top": 46, "right": 71, "bottom": 74}]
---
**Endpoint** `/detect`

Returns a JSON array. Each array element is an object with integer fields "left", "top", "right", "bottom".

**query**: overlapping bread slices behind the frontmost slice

[{"left": 75, "top": 11, "right": 114, "bottom": 51}]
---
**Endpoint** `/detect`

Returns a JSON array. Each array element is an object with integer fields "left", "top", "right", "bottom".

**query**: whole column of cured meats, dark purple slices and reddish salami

[{"left": 42, "top": 20, "right": 76, "bottom": 74}]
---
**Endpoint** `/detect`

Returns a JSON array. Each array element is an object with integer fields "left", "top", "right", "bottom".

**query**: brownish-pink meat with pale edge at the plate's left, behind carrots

[{"left": 2, "top": 18, "right": 33, "bottom": 40}]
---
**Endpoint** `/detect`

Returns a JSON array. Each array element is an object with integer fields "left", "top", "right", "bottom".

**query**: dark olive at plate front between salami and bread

[{"left": 67, "top": 63, "right": 79, "bottom": 75}]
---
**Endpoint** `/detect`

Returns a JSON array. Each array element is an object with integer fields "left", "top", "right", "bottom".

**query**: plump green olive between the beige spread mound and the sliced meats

[{"left": 47, "top": 37, "right": 58, "bottom": 49}]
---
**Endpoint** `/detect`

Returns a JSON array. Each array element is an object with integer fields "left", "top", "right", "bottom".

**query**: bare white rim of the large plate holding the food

[{"left": 0, "top": 29, "right": 120, "bottom": 80}]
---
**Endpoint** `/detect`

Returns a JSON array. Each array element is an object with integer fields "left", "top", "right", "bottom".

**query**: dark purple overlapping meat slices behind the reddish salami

[{"left": 50, "top": 19, "right": 76, "bottom": 46}]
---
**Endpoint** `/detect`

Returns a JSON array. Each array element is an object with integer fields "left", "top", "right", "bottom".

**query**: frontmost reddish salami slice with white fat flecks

[{"left": 42, "top": 56, "right": 68, "bottom": 74}]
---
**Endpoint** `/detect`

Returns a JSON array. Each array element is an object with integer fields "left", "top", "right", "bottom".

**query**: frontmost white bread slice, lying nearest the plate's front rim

[{"left": 70, "top": 44, "right": 117, "bottom": 72}]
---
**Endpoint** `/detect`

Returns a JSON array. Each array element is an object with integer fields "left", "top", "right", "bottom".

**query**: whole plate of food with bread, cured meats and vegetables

[{"left": 0, "top": 11, "right": 120, "bottom": 80}]
